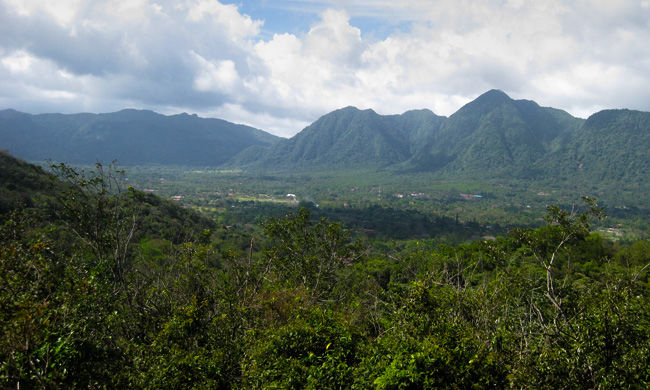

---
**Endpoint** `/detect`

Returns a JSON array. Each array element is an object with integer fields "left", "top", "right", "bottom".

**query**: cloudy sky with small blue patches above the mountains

[{"left": 0, "top": 0, "right": 650, "bottom": 137}]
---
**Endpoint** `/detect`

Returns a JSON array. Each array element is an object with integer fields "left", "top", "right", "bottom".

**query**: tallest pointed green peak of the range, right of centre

[{"left": 412, "top": 90, "right": 582, "bottom": 178}]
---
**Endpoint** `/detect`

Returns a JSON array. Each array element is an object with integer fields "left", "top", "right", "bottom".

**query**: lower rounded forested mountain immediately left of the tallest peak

[{"left": 232, "top": 107, "right": 444, "bottom": 168}]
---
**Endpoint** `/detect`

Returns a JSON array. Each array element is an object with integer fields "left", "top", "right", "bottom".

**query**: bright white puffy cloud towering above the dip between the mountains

[{"left": 249, "top": 10, "right": 365, "bottom": 111}]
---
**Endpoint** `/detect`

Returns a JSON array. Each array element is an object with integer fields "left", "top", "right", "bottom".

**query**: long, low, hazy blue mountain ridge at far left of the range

[{"left": 0, "top": 109, "right": 278, "bottom": 166}]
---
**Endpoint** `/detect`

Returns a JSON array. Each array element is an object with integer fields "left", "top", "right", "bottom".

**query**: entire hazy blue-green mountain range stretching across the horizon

[{"left": 0, "top": 90, "right": 650, "bottom": 186}]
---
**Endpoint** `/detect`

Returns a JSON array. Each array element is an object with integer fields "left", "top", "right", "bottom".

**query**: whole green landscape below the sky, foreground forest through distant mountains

[{"left": 0, "top": 91, "right": 650, "bottom": 389}]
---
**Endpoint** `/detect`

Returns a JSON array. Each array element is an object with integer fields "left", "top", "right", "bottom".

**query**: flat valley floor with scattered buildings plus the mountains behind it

[{"left": 0, "top": 90, "right": 650, "bottom": 238}]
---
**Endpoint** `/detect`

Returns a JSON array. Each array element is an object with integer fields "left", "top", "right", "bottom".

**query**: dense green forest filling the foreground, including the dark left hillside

[{"left": 0, "top": 153, "right": 650, "bottom": 389}]
